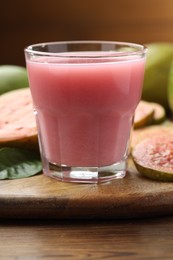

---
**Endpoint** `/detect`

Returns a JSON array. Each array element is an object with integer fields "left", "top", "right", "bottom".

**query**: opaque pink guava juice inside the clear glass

[{"left": 27, "top": 53, "right": 145, "bottom": 167}]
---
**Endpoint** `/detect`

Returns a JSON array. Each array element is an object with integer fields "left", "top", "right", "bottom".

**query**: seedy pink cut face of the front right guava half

[{"left": 133, "top": 134, "right": 173, "bottom": 171}]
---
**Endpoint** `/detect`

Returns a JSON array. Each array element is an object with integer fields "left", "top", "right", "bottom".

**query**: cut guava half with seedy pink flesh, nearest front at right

[{"left": 132, "top": 134, "right": 173, "bottom": 181}]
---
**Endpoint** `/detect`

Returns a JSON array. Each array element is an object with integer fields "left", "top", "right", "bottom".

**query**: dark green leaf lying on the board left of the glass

[{"left": 0, "top": 147, "right": 42, "bottom": 180}]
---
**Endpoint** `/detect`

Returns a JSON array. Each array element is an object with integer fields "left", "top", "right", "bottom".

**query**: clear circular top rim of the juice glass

[{"left": 24, "top": 40, "right": 148, "bottom": 58}]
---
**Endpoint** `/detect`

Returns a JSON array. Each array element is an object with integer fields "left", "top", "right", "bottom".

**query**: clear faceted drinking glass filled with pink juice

[{"left": 25, "top": 41, "right": 147, "bottom": 183}]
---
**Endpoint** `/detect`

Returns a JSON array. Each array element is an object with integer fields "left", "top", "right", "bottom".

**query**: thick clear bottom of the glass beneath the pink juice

[{"left": 43, "top": 160, "right": 126, "bottom": 183}]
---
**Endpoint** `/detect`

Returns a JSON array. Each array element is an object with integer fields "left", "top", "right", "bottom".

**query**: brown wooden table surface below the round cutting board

[{"left": 0, "top": 217, "right": 173, "bottom": 260}]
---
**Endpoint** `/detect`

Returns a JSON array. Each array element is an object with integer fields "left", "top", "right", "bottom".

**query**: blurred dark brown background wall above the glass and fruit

[{"left": 0, "top": 0, "right": 173, "bottom": 65}]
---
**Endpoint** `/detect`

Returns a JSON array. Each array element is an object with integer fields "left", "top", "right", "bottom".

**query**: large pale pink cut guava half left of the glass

[{"left": 0, "top": 88, "right": 38, "bottom": 149}]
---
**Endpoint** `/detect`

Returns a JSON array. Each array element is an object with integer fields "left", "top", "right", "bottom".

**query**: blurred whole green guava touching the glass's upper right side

[{"left": 142, "top": 42, "right": 173, "bottom": 109}]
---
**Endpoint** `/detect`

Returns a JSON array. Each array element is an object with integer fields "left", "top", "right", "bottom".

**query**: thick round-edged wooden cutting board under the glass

[{"left": 0, "top": 158, "right": 173, "bottom": 219}]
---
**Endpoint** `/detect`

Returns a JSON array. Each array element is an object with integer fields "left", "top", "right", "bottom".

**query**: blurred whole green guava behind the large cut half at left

[{"left": 0, "top": 65, "right": 29, "bottom": 95}]
